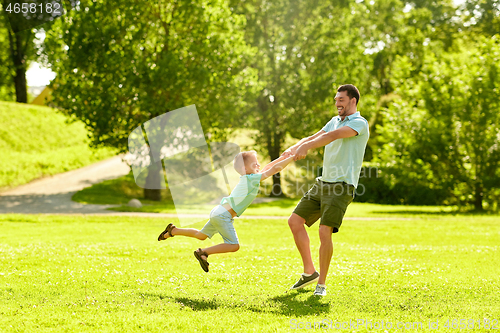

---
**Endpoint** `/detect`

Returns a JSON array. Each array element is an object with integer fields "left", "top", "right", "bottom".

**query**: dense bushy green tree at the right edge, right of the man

[{"left": 380, "top": 37, "right": 500, "bottom": 210}]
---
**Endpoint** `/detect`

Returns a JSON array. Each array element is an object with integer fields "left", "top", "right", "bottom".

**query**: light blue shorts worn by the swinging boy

[{"left": 200, "top": 205, "right": 239, "bottom": 244}]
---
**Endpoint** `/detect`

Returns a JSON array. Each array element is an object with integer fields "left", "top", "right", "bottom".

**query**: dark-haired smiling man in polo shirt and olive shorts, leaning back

[{"left": 283, "top": 84, "right": 370, "bottom": 296}]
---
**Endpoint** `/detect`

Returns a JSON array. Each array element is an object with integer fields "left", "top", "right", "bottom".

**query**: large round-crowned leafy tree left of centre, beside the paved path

[{"left": 41, "top": 0, "right": 253, "bottom": 199}]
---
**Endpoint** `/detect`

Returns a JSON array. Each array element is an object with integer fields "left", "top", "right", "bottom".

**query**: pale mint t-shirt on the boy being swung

[{"left": 220, "top": 173, "right": 262, "bottom": 216}]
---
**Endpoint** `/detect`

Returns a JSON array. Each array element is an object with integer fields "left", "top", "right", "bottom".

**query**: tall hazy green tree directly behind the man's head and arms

[{"left": 233, "top": 0, "right": 371, "bottom": 196}]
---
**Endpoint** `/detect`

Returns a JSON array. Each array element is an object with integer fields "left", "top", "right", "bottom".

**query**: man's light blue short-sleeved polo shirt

[{"left": 321, "top": 112, "right": 370, "bottom": 188}]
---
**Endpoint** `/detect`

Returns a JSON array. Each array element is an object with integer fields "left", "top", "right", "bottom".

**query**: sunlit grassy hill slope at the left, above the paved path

[{"left": 0, "top": 102, "right": 116, "bottom": 190}]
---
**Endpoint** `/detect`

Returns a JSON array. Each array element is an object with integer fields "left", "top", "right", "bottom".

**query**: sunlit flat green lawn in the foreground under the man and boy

[{"left": 0, "top": 211, "right": 500, "bottom": 332}]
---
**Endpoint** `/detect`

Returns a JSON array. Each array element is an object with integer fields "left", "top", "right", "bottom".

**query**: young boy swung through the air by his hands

[{"left": 158, "top": 150, "right": 293, "bottom": 272}]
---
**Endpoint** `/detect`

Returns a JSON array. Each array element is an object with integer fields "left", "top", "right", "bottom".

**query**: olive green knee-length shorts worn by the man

[{"left": 293, "top": 178, "right": 355, "bottom": 233}]
